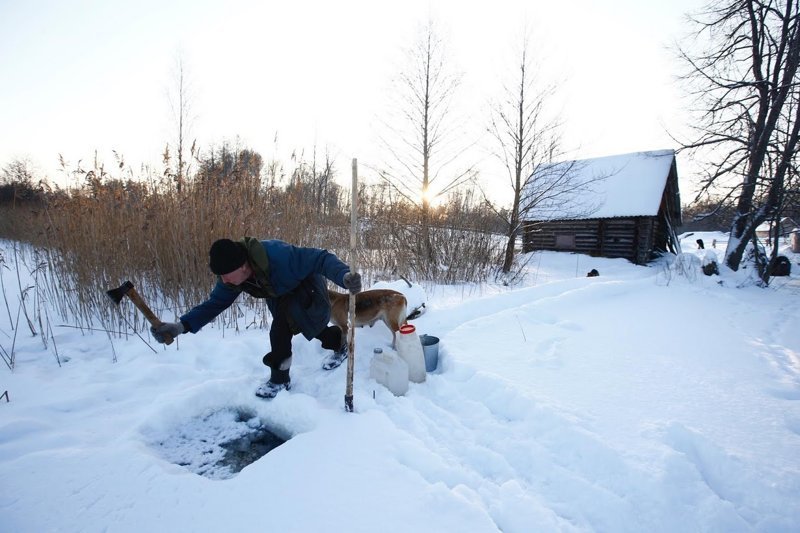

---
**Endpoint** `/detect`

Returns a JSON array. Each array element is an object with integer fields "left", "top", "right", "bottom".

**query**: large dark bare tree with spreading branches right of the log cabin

[{"left": 679, "top": 0, "right": 800, "bottom": 282}]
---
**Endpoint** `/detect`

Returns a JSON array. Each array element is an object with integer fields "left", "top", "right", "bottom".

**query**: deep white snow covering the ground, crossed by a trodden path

[{"left": 0, "top": 234, "right": 800, "bottom": 533}]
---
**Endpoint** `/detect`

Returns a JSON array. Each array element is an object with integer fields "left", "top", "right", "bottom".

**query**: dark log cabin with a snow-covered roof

[{"left": 522, "top": 150, "right": 681, "bottom": 264}]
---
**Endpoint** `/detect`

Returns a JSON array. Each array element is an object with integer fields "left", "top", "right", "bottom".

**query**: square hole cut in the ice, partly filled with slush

[{"left": 151, "top": 407, "right": 286, "bottom": 479}]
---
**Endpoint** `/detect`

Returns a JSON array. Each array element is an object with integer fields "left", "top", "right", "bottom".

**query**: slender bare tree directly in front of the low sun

[{"left": 378, "top": 21, "right": 474, "bottom": 261}]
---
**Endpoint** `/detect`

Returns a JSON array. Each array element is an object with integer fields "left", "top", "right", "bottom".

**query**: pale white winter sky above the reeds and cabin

[{"left": 0, "top": 0, "right": 704, "bottom": 203}]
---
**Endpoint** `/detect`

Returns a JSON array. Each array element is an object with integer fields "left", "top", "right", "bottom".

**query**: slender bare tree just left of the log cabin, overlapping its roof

[{"left": 489, "top": 34, "right": 567, "bottom": 273}]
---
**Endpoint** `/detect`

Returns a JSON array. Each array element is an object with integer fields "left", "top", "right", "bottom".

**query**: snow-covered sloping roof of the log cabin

[{"left": 526, "top": 150, "right": 675, "bottom": 220}]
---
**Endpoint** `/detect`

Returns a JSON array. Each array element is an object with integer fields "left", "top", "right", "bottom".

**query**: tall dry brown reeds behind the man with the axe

[{"left": 0, "top": 150, "right": 501, "bottom": 344}]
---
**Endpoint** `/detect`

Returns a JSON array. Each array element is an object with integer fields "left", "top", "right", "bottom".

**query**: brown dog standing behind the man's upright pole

[{"left": 328, "top": 289, "right": 408, "bottom": 348}]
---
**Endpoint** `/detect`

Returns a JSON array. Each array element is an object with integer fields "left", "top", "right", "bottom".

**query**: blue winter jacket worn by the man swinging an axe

[{"left": 180, "top": 240, "right": 350, "bottom": 340}]
